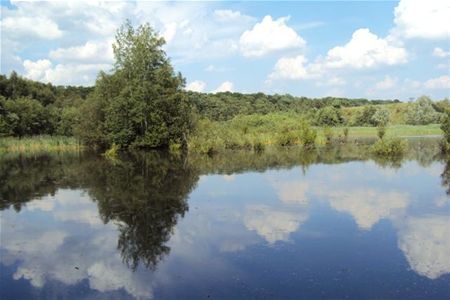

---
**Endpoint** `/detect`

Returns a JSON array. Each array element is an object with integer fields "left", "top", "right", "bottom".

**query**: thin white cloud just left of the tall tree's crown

[{"left": 49, "top": 39, "right": 114, "bottom": 63}]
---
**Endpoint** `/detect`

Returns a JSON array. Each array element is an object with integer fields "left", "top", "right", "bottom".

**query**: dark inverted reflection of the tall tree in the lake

[{"left": 81, "top": 152, "right": 198, "bottom": 270}]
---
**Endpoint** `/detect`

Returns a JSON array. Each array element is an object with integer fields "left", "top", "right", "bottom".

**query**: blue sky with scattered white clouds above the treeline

[{"left": 0, "top": 0, "right": 450, "bottom": 101}]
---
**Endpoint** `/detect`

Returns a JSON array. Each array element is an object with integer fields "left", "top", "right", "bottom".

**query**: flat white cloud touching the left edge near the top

[{"left": 0, "top": 16, "right": 63, "bottom": 40}]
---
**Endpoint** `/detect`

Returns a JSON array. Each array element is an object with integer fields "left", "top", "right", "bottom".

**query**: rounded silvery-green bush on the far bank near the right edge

[{"left": 406, "top": 96, "right": 442, "bottom": 125}]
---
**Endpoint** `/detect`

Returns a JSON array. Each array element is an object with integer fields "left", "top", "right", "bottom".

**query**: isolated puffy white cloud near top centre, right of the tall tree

[{"left": 239, "top": 16, "right": 306, "bottom": 57}]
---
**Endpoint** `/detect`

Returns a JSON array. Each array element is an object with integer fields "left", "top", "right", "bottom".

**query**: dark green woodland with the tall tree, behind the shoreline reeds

[{"left": 0, "top": 23, "right": 450, "bottom": 148}]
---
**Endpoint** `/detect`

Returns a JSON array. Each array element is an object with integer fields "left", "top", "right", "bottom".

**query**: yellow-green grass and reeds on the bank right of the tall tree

[{"left": 188, "top": 113, "right": 442, "bottom": 154}]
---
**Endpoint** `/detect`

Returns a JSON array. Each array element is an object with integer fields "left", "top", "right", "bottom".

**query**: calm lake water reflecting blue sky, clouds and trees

[{"left": 0, "top": 139, "right": 450, "bottom": 299}]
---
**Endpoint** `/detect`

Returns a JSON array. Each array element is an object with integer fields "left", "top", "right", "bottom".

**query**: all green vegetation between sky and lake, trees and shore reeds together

[{"left": 0, "top": 22, "right": 450, "bottom": 155}]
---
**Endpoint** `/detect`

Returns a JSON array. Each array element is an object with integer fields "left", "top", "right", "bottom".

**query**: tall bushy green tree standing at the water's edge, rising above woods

[{"left": 78, "top": 22, "right": 190, "bottom": 148}]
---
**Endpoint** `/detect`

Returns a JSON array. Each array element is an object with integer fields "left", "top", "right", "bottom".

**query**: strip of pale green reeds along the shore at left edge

[{"left": 0, "top": 135, "right": 83, "bottom": 153}]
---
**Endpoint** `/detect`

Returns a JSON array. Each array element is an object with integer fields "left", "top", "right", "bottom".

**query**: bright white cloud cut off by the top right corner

[{"left": 393, "top": 0, "right": 450, "bottom": 39}]
